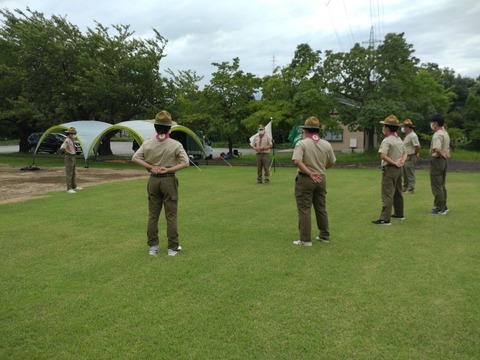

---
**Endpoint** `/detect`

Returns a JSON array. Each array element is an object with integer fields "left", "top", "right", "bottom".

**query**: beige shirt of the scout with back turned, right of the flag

[{"left": 292, "top": 138, "right": 337, "bottom": 175}]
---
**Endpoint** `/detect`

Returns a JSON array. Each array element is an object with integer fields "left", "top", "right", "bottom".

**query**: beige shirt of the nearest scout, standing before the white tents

[{"left": 133, "top": 138, "right": 189, "bottom": 167}]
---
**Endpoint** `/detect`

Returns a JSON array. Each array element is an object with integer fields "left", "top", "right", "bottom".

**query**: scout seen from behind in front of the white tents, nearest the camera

[{"left": 132, "top": 110, "right": 189, "bottom": 256}]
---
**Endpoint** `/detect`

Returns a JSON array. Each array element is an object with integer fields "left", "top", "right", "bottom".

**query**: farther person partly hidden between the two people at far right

[{"left": 401, "top": 119, "right": 420, "bottom": 194}]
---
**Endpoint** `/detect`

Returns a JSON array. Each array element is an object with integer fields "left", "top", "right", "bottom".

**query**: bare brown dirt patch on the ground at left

[{"left": 0, "top": 164, "right": 147, "bottom": 204}]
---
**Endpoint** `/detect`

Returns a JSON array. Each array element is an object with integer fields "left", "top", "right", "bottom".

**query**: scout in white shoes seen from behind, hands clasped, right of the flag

[{"left": 292, "top": 116, "right": 337, "bottom": 246}]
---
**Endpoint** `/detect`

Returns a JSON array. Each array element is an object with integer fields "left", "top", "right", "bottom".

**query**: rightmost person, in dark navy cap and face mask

[{"left": 430, "top": 114, "right": 450, "bottom": 215}]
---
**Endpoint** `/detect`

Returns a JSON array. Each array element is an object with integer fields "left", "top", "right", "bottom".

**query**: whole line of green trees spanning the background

[{"left": 0, "top": 8, "right": 480, "bottom": 152}]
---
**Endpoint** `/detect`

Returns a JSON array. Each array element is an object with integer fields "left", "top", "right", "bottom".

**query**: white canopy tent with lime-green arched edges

[{"left": 33, "top": 120, "right": 204, "bottom": 167}]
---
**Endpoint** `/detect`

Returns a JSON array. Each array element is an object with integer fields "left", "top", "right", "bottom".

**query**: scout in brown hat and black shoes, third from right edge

[{"left": 372, "top": 115, "right": 407, "bottom": 225}]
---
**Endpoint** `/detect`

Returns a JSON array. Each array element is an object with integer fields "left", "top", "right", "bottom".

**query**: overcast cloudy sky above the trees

[{"left": 0, "top": 0, "right": 480, "bottom": 82}]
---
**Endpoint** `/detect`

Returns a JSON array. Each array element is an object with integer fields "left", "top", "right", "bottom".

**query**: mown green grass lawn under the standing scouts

[{"left": 0, "top": 166, "right": 480, "bottom": 359}]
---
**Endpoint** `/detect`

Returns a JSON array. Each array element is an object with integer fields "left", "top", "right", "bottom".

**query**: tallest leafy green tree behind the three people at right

[{"left": 323, "top": 33, "right": 451, "bottom": 150}]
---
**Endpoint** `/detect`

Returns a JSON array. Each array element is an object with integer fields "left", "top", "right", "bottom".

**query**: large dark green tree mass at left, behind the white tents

[{"left": 0, "top": 8, "right": 166, "bottom": 153}]
